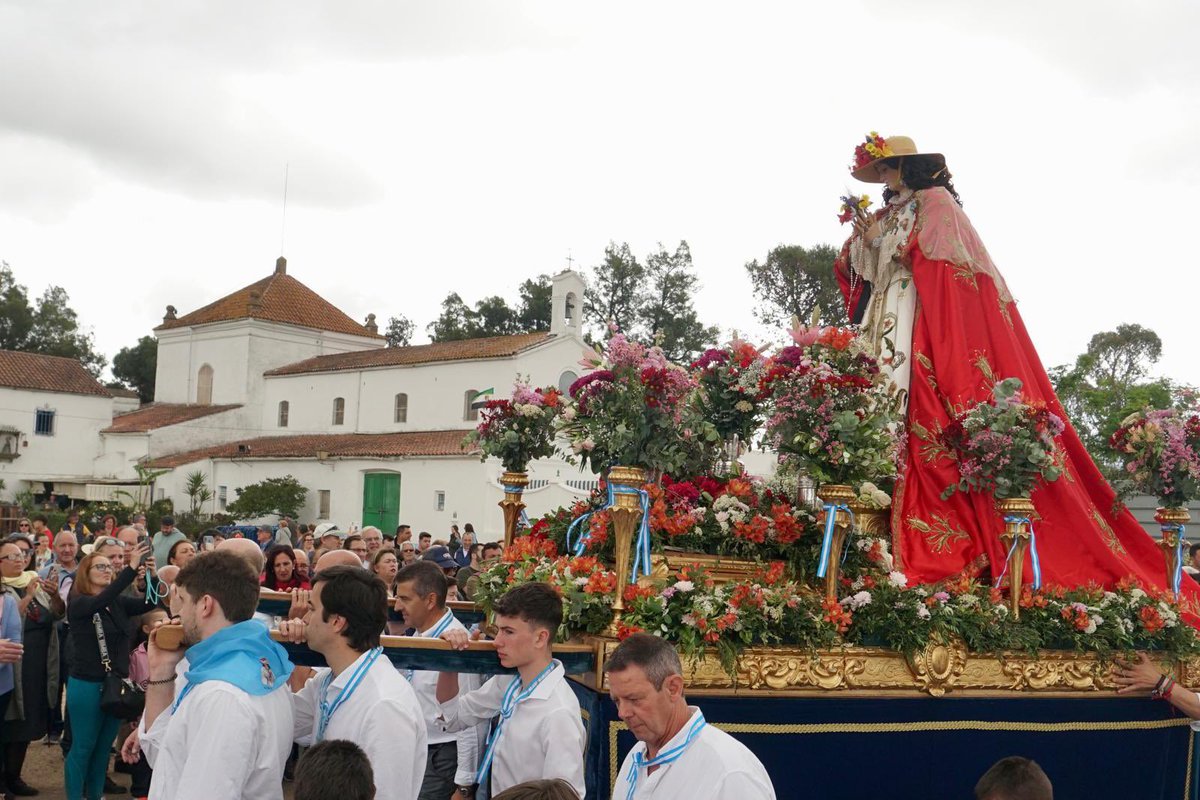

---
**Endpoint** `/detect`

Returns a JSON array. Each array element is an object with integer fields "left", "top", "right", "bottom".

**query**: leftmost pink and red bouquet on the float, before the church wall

[{"left": 463, "top": 380, "right": 563, "bottom": 473}]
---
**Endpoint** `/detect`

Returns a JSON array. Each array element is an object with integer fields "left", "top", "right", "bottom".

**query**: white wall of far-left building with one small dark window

[{"left": 0, "top": 389, "right": 113, "bottom": 497}]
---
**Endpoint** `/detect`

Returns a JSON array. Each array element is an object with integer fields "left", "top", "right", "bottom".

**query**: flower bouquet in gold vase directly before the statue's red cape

[{"left": 941, "top": 378, "right": 1066, "bottom": 500}]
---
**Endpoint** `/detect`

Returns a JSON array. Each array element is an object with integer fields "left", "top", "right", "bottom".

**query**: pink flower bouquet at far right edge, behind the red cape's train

[{"left": 1109, "top": 409, "right": 1200, "bottom": 507}]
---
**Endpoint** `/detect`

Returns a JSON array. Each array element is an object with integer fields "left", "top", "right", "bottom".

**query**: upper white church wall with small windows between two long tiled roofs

[{"left": 263, "top": 337, "right": 583, "bottom": 435}]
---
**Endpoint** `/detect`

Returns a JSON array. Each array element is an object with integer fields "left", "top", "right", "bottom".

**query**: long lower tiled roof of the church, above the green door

[{"left": 149, "top": 429, "right": 478, "bottom": 469}]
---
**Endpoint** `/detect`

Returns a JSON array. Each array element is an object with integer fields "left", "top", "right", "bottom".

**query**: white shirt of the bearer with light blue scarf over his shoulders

[{"left": 138, "top": 680, "right": 292, "bottom": 800}]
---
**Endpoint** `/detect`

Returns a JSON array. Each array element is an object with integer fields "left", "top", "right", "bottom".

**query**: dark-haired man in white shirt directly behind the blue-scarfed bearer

[{"left": 280, "top": 565, "right": 429, "bottom": 800}]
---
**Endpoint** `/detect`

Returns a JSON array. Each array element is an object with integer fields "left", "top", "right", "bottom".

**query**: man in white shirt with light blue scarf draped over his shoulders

[{"left": 138, "top": 552, "right": 292, "bottom": 800}]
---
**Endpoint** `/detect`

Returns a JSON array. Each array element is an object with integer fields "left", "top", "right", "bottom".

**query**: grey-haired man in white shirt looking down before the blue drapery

[{"left": 604, "top": 633, "right": 775, "bottom": 800}]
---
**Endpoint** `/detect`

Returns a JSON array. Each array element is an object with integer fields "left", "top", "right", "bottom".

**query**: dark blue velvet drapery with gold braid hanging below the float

[{"left": 575, "top": 684, "right": 1200, "bottom": 800}]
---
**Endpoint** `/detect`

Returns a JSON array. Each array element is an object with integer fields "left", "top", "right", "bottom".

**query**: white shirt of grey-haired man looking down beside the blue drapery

[{"left": 612, "top": 706, "right": 775, "bottom": 800}]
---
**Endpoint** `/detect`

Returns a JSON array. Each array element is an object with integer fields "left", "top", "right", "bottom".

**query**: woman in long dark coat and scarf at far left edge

[{"left": 0, "top": 536, "right": 66, "bottom": 796}]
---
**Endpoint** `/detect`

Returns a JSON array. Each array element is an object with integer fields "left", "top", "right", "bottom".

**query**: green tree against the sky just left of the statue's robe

[{"left": 745, "top": 245, "right": 850, "bottom": 327}]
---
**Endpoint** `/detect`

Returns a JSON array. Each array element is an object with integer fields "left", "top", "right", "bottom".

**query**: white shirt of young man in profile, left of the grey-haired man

[{"left": 442, "top": 661, "right": 587, "bottom": 798}]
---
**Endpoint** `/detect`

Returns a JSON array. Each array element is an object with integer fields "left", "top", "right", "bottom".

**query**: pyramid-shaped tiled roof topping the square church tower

[{"left": 155, "top": 259, "right": 383, "bottom": 338}]
